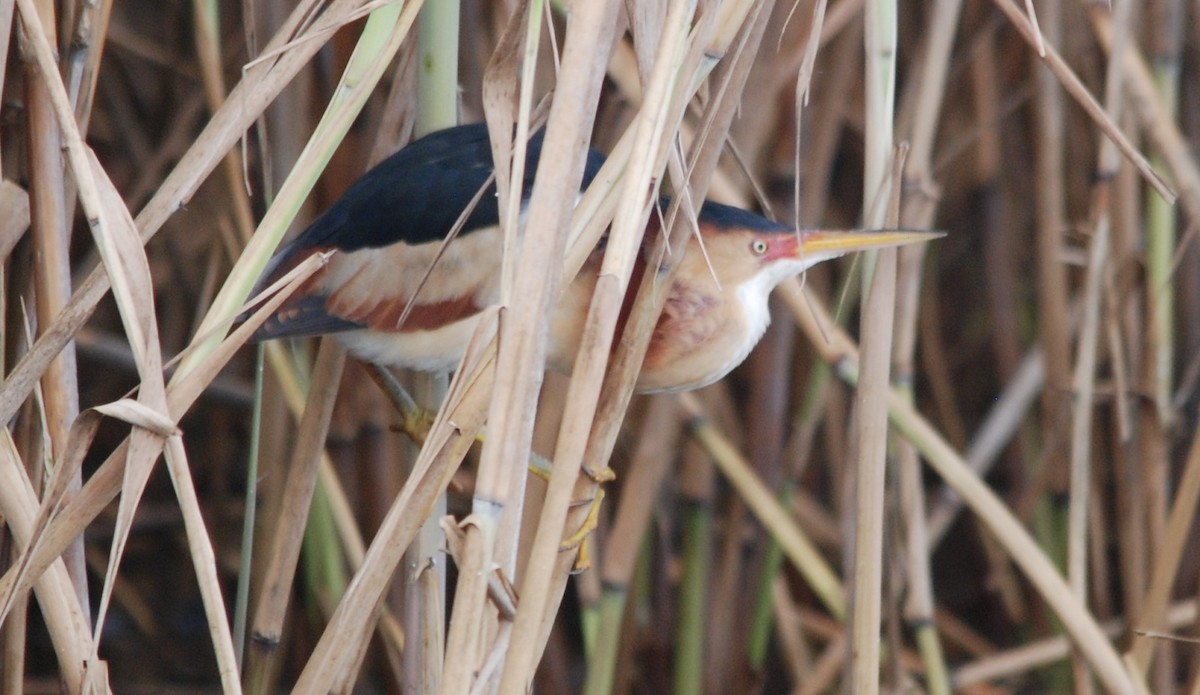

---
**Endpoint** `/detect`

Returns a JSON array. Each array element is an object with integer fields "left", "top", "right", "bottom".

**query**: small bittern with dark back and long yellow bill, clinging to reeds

[{"left": 254, "top": 124, "right": 941, "bottom": 393}]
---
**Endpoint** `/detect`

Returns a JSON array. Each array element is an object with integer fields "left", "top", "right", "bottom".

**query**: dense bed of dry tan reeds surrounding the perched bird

[{"left": 0, "top": 0, "right": 1200, "bottom": 695}]
